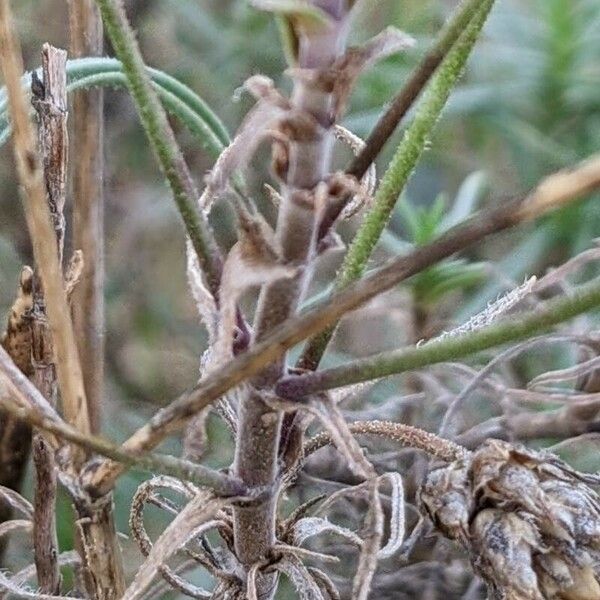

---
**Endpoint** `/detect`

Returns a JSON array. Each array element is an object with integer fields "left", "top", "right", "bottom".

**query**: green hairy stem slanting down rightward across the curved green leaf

[{"left": 96, "top": 0, "right": 222, "bottom": 297}]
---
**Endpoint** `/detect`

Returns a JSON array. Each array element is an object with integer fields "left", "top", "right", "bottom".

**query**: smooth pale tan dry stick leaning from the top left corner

[{"left": 0, "top": 0, "right": 90, "bottom": 446}]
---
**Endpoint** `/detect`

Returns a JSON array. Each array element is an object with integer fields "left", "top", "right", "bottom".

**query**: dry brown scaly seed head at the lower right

[{"left": 420, "top": 440, "right": 600, "bottom": 600}]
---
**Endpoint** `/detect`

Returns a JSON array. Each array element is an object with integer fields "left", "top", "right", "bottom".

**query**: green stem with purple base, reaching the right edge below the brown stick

[{"left": 276, "top": 280, "right": 600, "bottom": 398}]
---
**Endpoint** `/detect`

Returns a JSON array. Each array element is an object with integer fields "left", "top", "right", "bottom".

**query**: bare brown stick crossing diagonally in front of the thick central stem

[{"left": 87, "top": 155, "right": 600, "bottom": 491}]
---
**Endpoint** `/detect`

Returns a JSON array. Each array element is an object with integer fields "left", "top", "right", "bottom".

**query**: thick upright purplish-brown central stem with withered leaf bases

[{"left": 234, "top": 4, "right": 346, "bottom": 580}]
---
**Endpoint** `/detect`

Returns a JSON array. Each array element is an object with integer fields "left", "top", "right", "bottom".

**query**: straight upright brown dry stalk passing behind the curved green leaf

[{"left": 69, "top": 0, "right": 104, "bottom": 433}]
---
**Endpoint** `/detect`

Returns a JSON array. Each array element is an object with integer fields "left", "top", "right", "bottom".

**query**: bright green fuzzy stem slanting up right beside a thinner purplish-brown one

[{"left": 298, "top": 0, "right": 494, "bottom": 371}]
